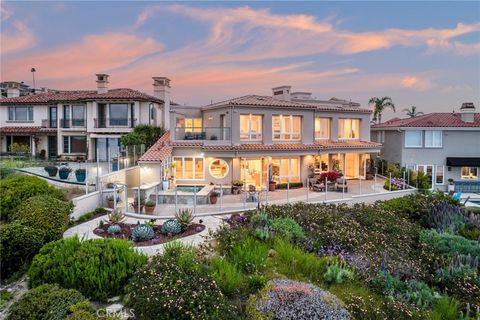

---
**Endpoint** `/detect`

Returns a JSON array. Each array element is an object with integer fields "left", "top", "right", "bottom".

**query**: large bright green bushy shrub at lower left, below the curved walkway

[{"left": 28, "top": 237, "right": 146, "bottom": 301}]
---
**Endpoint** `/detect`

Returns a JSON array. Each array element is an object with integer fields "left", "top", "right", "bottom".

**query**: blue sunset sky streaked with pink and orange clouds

[{"left": 1, "top": 1, "right": 480, "bottom": 118}]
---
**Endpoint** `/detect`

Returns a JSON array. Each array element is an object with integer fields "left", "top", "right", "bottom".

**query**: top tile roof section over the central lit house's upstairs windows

[{"left": 203, "top": 94, "right": 316, "bottom": 110}]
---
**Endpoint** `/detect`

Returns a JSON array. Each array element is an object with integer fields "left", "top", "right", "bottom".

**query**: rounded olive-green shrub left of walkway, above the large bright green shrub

[{"left": 11, "top": 195, "right": 73, "bottom": 243}]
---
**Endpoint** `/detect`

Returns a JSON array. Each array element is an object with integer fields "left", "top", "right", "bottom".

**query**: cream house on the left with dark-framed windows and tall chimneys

[{"left": 0, "top": 74, "right": 170, "bottom": 161}]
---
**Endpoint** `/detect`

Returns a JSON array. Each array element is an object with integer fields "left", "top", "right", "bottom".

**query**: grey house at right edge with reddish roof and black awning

[{"left": 372, "top": 103, "right": 480, "bottom": 192}]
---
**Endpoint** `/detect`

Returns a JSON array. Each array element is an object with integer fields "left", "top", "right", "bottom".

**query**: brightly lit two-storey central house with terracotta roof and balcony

[{"left": 140, "top": 86, "right": 380, "bottom": 187}]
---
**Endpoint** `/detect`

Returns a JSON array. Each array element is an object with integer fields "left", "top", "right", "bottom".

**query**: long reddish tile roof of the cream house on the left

[{"left": 0, "top": 88, "right": 163, "bottom": 105}]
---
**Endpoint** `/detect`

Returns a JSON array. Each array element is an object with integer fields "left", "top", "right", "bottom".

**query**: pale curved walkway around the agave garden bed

[{"left": 63, "top": 215, "right": 225, "bottom": 256}]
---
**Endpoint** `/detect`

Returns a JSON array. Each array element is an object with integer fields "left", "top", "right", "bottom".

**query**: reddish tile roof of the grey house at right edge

[{"left": 371, "top": 113, "right": 480, "bottom": 129}]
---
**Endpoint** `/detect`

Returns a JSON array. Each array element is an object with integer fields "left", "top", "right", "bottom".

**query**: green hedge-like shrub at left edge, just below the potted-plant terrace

[{"left": 0, "top": 174, "right": 65, "bottom": 220}]
